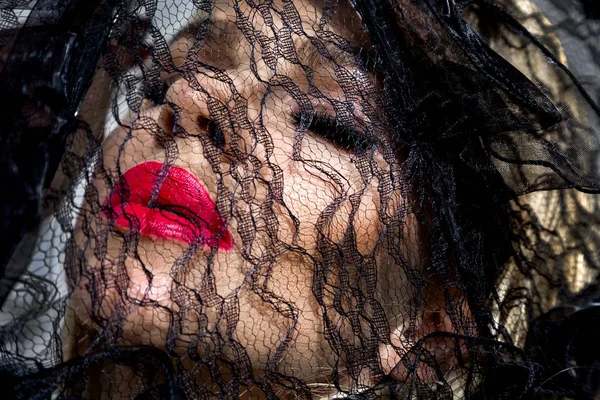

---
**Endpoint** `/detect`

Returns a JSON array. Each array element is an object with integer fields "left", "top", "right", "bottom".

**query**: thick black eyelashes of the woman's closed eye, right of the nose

[{"left": 292, "top": 111, "right": 374, "bottom": 154}]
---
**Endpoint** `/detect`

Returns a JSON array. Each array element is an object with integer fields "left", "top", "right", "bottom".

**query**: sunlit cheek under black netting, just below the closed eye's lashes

[{"left": 277, "top": 155, "right": 403, "bottom": 255}]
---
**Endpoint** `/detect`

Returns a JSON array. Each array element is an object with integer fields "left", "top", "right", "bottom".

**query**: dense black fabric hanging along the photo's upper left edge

[{"left": 0, "top": 1, "right": 116, "bottom": 303}]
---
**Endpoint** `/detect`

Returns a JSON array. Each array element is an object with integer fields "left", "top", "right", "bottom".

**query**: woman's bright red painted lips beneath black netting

[{"left": 102, "top": 161, "right": 233, "bottom": 250}]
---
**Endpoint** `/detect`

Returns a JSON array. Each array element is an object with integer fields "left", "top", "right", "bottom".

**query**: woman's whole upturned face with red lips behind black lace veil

[{"left": 69, "top": 0, "right": 420, "bottom": 394}]
